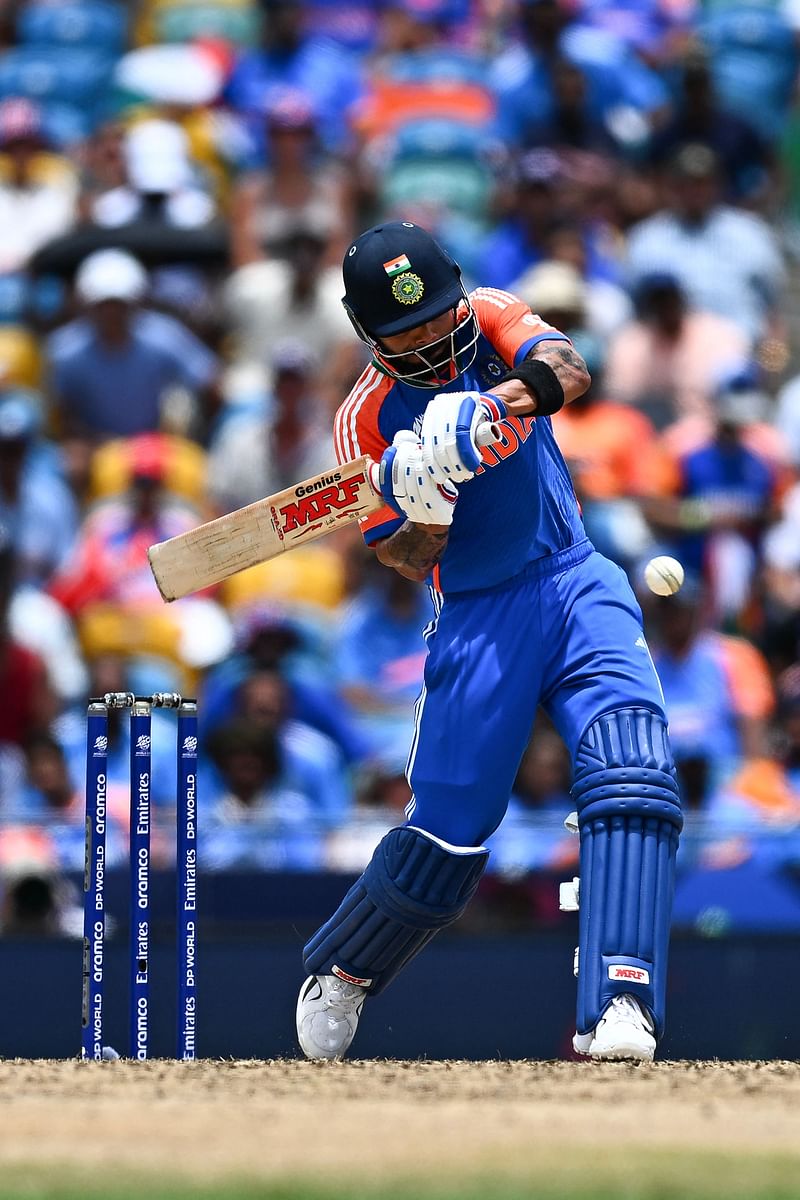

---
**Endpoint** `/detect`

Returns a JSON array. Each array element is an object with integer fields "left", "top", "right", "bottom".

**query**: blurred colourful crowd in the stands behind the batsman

[{"left": 0, "top": 0, "right": 800, "bottom": 928}]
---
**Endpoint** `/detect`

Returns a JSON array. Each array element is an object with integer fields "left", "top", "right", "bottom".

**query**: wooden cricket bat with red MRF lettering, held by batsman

[{"left": 148, "top": 421, "right": 501, "bottom": 601}]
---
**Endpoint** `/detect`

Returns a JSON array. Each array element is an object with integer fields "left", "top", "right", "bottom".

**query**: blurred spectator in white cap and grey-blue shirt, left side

[{"left": 48, "top": 250, "right": 218, "bottom": 446}]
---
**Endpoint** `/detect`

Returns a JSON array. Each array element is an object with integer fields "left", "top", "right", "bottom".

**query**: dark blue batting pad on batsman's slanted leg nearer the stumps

[{"left": 303, "top": 826, "right": 489, "bottom": 995}]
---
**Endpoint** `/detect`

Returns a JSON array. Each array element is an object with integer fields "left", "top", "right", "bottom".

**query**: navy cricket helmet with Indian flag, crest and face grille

[{"left": 342, "top": 221, "right": 479, "bottom": 388}]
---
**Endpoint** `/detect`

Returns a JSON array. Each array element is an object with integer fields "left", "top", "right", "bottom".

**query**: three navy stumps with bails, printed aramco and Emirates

[{"left": 80, "top": 691, "right": 198, "bottom": 1061}]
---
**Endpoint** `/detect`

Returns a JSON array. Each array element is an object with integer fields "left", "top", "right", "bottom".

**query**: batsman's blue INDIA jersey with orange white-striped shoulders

[{"left": 333, "top": 288, "right": 585, "bottom": 593}]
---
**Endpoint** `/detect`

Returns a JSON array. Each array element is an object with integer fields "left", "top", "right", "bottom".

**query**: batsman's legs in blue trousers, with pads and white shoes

[{"left": 297, "top": 542, "right": 681, "bottom": 1058}]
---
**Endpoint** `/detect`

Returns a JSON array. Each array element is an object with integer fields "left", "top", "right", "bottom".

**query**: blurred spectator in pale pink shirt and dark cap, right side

[{"left": 606, "top": 272, "right": 748, "bottom": 428}]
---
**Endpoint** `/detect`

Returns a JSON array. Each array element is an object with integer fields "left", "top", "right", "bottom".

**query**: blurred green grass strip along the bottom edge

[{"left": 0, "top": 1147, "right": 800, "bottom": 1200}]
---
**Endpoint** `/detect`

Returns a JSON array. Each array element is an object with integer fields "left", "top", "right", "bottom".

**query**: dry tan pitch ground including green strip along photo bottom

[{"left": 0, "top": 1061, "right": 800, "bottom": 1200}]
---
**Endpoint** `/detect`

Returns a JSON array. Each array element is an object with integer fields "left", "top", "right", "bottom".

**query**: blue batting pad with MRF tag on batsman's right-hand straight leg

[{"left": 572, "top": 708, "right": 682, "bottom": 1036}]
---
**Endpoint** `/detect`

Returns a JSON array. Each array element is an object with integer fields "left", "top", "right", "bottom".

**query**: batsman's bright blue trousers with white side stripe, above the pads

[{"left": 408, "top": 539, "right": 664, "bottom": 846}]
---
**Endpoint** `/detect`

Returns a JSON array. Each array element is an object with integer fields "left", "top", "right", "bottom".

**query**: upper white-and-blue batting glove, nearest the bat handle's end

[{"left": 420, "top": 391, "right": 506, "bottom": 484}]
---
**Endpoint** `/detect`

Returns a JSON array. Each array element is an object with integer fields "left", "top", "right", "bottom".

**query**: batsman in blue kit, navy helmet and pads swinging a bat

[{"left": 296, "top": 221, "right": 682, "bottom": 1061}]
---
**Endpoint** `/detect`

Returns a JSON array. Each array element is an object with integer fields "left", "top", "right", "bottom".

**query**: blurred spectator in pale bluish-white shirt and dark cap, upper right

[{"left": 627, "top": 145, "right": 786, "bottom": 346}]
